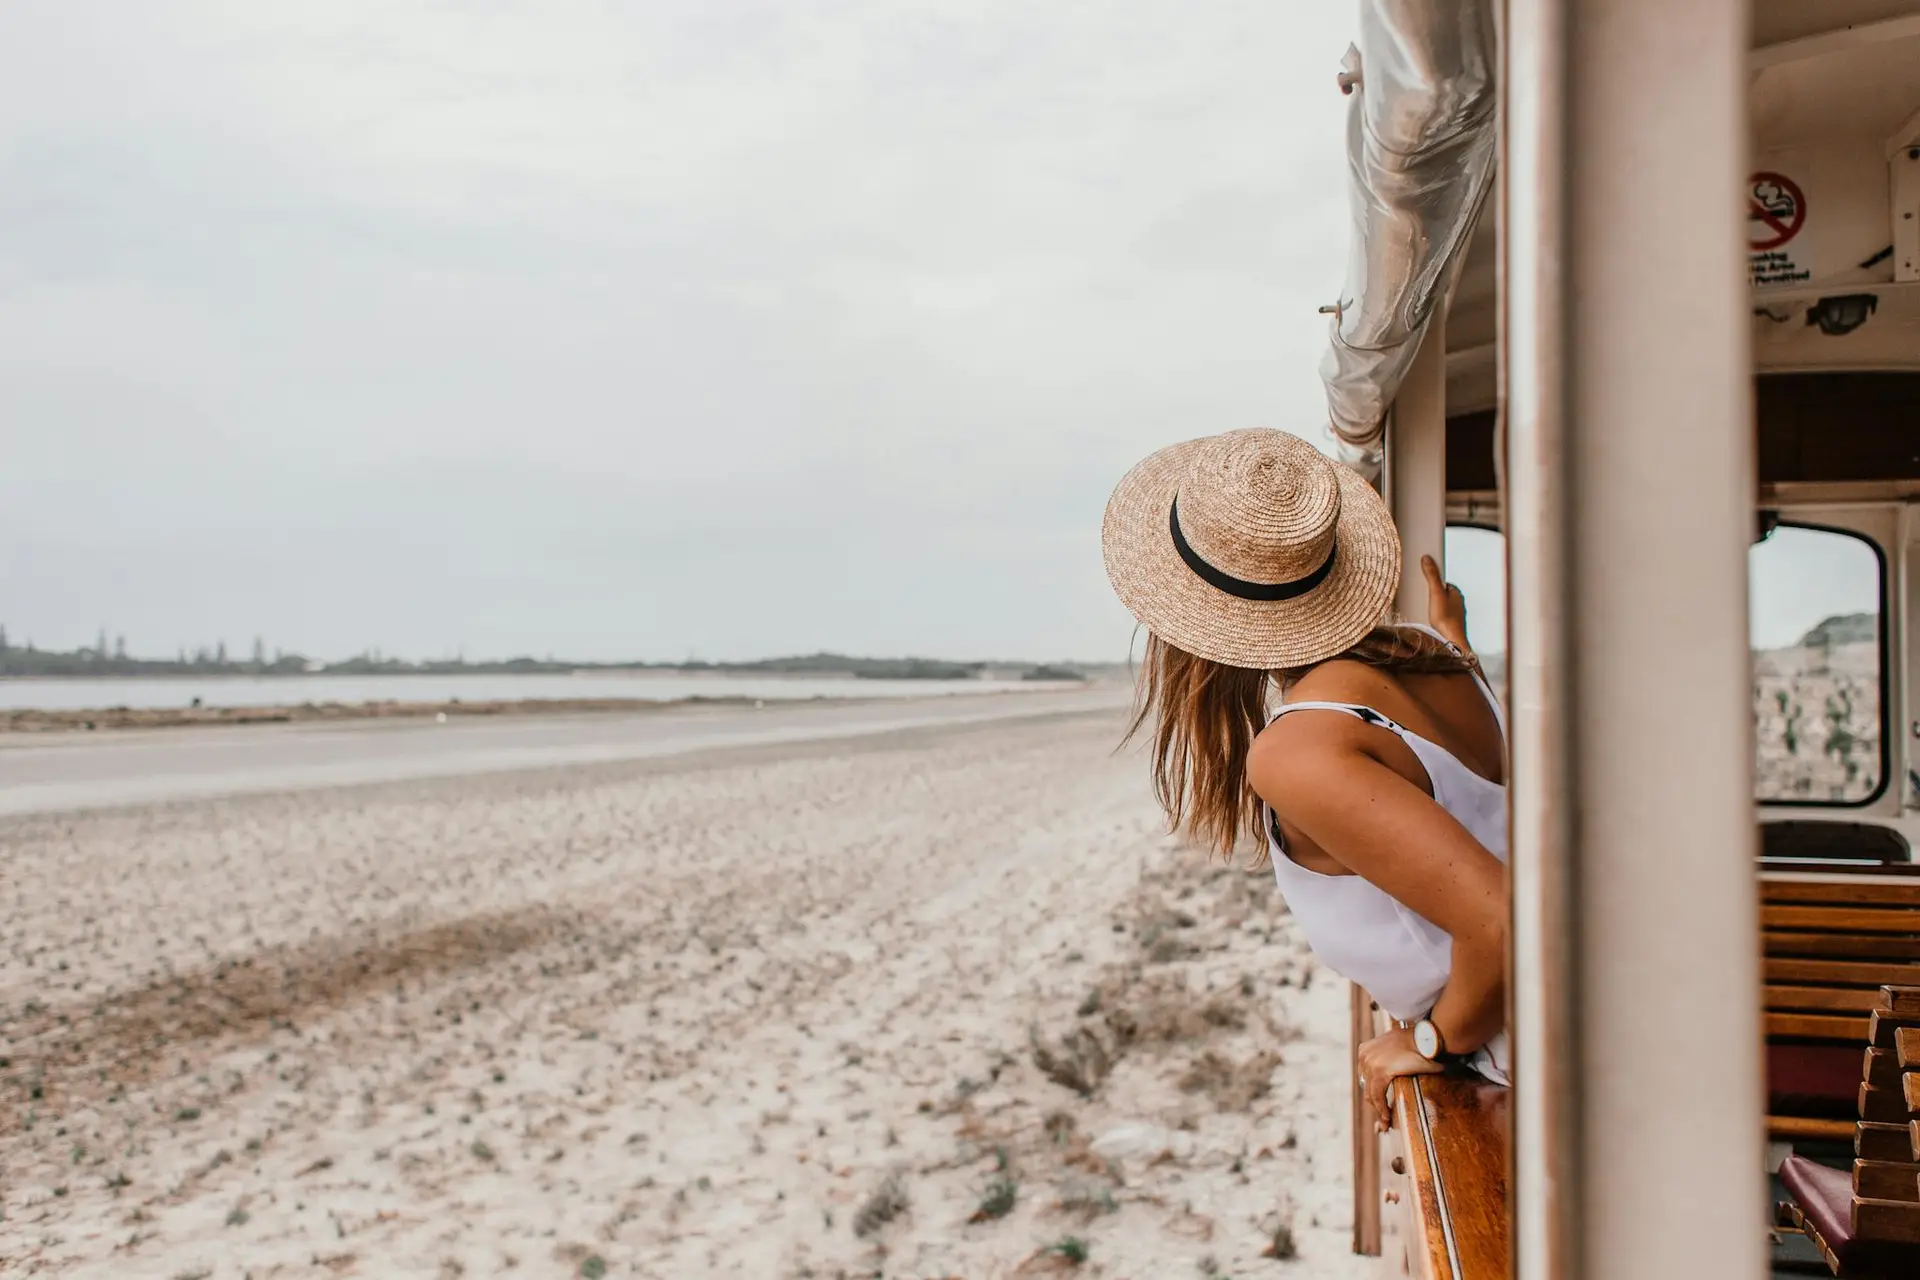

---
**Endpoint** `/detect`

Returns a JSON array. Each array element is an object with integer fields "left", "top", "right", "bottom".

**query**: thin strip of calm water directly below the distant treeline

[{"left": 0, "top": 672, "right": 1058, "bottom": 710}]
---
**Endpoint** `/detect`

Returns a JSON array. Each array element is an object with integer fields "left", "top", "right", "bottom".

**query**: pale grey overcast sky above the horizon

[{"left": 0, "top": 0, "right": 1382, "bottom": 658}]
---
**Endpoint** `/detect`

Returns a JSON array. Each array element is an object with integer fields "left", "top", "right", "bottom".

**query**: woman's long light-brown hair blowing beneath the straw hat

[{"left": 1127, "top": 626, "right": 1473, "bottom": 862}]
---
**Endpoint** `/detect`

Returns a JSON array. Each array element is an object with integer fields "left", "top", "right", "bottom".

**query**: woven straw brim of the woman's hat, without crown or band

[{"left": 1100, "top": 438, "right": 1400, "bottom": 670}]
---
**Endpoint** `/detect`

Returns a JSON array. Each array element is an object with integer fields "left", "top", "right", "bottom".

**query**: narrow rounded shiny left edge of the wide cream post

[{"left": 1500, "top": 0, "right": 1582, "bottom": 1280}]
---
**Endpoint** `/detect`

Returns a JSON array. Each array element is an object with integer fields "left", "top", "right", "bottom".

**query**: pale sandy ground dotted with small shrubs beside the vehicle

[{"left": 0, "top": 708, "right": 1371, "bottom": 1280}]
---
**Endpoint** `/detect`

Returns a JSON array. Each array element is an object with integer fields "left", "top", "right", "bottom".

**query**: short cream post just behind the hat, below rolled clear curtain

[{"left": 1386, "top": 309, "right": 1446, "bottom": 622}]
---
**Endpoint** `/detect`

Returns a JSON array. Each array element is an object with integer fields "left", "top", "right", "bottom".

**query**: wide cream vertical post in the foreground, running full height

[{"left": 1503, "top": 0, "right": 1766, "bottom": 1280}]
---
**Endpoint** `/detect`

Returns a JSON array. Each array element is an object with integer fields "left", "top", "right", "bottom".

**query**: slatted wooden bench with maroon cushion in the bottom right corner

[{"left": 1778, "top": 986, "right": 1920, "bottom": 1276}]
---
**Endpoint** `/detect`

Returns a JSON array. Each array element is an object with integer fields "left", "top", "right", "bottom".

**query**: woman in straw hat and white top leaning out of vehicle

[{"left": 1100, "top": 430, "right": 1507, "bottom": 1126}]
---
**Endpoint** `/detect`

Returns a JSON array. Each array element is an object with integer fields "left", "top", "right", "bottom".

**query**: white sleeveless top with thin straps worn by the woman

[{"left": 1261, "top": 624, "right": 1509, "bottom": 1084}]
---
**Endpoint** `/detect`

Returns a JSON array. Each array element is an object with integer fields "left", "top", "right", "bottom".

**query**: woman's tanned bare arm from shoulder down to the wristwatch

[{"left": 1248, "top": 714, "right": 1507, "bottom": 1054}]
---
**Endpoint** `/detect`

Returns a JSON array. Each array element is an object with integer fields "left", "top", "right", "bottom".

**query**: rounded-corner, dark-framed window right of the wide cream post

[{"left": 1747, "top": 524, "right": 1885, "bottom": 804}]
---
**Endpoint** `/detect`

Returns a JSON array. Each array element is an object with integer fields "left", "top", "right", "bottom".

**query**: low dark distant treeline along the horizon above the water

[{"left": 0, "top": 628, "right": 1087, "bottom": 679}]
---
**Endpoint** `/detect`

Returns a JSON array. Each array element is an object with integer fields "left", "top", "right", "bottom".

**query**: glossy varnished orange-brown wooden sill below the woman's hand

[{"left": 1392, "top": 1075, "right": 1513, "bottom": 1280}]
